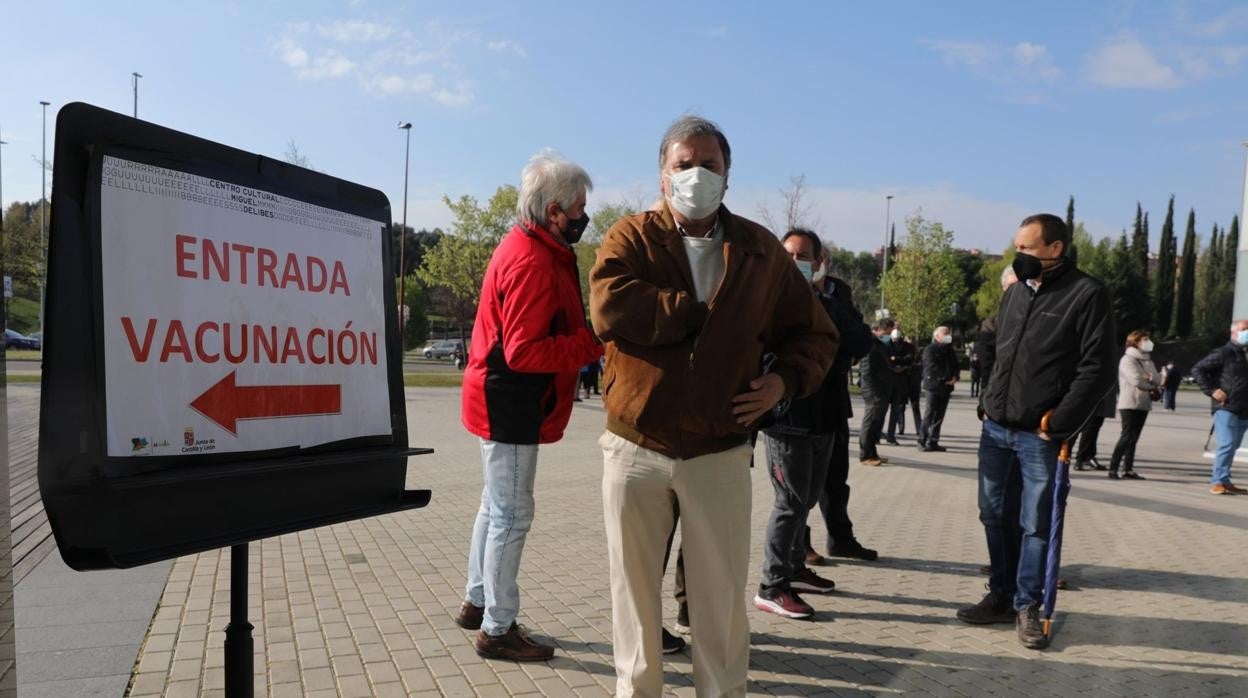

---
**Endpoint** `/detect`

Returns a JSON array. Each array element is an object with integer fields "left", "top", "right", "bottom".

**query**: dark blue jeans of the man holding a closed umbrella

[{"left": 980, "top": 420, "right": 1062, "bottom": 611}]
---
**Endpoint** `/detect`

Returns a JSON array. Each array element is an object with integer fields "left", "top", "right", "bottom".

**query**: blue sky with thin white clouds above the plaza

[{"left": 0, "top": 0, "right": 1248, "bottom": 250}]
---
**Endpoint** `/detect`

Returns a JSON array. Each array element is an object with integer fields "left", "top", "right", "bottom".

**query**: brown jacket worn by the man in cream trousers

[{"left": 589, "top": 205, "right": 839, "bottom": 458}]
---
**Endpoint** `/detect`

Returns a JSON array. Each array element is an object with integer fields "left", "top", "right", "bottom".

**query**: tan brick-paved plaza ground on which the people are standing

[{"left": 9, "top": 385, "right": 1248, "bottom": 698}]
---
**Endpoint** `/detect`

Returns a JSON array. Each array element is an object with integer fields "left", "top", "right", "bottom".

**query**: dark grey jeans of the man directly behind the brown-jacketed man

[{"left": 763, "top": 435, "right": 832, "bottom": 587}]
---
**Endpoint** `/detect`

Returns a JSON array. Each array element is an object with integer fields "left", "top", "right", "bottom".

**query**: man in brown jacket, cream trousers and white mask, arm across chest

[{"left": 590, "top": 116, "right": 837, "bottom": 696}]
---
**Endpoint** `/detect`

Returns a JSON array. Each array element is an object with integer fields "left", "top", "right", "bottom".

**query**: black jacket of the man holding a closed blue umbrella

[{"left": 980, "top": 262, "right": 1118, "bottom": 438}]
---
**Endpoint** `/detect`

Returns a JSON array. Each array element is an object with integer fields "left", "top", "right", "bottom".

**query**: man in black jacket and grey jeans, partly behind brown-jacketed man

[{"left": 754, "top": 229, "right": 875, "bottom": 618}]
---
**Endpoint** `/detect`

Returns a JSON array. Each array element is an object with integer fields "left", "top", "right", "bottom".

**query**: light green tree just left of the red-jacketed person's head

[{"left": 417, "top": 185, "right": 518, "bottom": 345}]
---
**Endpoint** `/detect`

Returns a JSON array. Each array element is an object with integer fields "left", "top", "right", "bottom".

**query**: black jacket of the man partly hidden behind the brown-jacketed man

[{"left": 764, "top": 277, "right": 879, "bottom": 436}]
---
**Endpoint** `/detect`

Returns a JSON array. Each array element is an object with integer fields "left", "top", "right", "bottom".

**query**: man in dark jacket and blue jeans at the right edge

[{"left": 1192, "top": 320, "right": 1248, "bottom": 494}]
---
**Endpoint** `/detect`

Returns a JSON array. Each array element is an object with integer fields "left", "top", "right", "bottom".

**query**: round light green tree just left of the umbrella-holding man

[{"left": 881, "top": 214, "right": 966, "bottom": 341}]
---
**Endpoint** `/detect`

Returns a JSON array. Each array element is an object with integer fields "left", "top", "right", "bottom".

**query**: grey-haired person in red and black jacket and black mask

[{"left": 456, "top": 151, "right": 603, "bottom": 662}]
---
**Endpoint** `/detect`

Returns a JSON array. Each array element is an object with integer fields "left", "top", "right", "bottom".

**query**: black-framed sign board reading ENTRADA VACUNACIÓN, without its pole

[{"left": 39, "top": 104, "right": 431, "bottom": 569}]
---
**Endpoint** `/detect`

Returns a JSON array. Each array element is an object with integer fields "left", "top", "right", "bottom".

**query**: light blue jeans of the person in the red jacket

[{"left": 464, "top": 438, "right": 538, "bottom": 636}]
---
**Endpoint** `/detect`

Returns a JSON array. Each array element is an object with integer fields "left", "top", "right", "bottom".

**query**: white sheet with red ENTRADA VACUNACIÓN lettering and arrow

[{"left": 100, "top": 157, "right": 391, "bottom": 456}]
